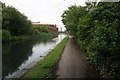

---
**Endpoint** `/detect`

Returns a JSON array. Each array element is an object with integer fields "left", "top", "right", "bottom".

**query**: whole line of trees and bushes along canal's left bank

[{"left": 0, "top": 2, "right": 49, "bottom": 41}]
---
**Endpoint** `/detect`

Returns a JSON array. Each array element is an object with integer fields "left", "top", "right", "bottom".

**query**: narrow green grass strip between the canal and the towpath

[{"left": 21, "top": 36, "right": 68, "bottom": 80}]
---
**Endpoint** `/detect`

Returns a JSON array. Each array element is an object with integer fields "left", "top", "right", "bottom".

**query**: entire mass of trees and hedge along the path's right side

[{"left": 62, "top": 1, "right": 120, "bottom": 78}]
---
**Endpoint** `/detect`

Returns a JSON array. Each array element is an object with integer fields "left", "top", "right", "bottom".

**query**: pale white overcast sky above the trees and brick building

[{"left": 1, "top": 0, "right": 86, "bottom": 30}]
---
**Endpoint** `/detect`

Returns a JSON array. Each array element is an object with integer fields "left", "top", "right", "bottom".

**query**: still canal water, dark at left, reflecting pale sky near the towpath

[{"left": 2, "top": 34, "right": 66, "bottom": 78}]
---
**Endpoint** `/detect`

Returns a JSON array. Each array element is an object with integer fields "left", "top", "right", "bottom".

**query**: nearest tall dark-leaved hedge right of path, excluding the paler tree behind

[{"left": 76, "top": 3, "right": 120, "bottom": 78}]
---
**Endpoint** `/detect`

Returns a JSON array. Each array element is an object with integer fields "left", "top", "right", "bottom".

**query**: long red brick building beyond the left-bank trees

[{"left": 32, "top": 22, "right": 58, "bottom": 33}]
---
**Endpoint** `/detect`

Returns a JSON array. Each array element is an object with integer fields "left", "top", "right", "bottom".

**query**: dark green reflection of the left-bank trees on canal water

[{"left": 2, "top": 36, "right": 57, "bottom": 77}]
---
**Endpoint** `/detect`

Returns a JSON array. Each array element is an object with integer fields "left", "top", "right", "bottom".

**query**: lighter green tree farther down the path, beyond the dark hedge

[{"left": 61, "top": 5, "right": 87, "bottom": 35}]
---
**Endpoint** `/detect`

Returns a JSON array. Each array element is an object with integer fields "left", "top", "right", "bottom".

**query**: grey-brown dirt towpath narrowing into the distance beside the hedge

[{"left": 57, "top": 37, "right": 99, "bottom": 78}]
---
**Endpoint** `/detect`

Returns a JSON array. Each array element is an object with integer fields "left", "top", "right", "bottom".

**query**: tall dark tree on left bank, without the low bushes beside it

[{"left": 2, "top": 4, "right": 32, "bottom": 35}]
